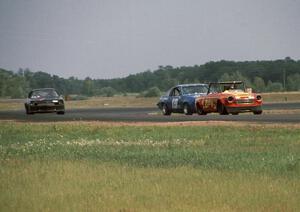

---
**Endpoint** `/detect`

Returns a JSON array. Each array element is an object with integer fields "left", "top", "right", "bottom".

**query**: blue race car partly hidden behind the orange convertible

[{"left": 157, "top": 84, "right": 208, "bottom": 115}]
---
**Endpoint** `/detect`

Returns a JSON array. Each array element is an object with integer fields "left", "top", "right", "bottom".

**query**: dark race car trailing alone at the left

[{"left": 25, "top": 88, "right": 65, "bottom": 114}]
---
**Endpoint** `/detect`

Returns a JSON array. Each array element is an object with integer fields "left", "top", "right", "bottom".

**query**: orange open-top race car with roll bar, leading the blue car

[{"left": 196, "top": 81, "right": 262, "bottom": 115}]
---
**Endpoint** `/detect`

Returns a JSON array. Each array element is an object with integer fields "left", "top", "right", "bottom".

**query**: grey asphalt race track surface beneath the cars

[{"left": 0, "top": 103, "right": 300, "bottom": 124}]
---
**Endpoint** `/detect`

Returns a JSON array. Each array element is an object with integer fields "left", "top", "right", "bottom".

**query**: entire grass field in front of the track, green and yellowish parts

[{"left": 0, "top": 122, "right": 300, "bottom": 211}]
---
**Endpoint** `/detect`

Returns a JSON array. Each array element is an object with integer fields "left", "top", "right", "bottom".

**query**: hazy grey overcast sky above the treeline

[{"left": 0, "top": 0, "right": 300, "bottom": 79}]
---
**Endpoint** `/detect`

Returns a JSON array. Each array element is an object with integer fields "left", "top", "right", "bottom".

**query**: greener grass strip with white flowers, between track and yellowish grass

[{"left": 0, "top": 123, "right": 300, "bottom": 174}]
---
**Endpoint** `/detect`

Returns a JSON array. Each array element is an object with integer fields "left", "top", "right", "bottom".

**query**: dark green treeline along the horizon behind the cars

[{"left": 0, "top": 57, "right": 300, "bottom": 98}]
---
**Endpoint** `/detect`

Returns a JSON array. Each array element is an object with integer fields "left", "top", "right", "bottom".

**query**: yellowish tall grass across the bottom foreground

[{"left": 0, "top": 160, "right": 300, "bottom": 211}]
